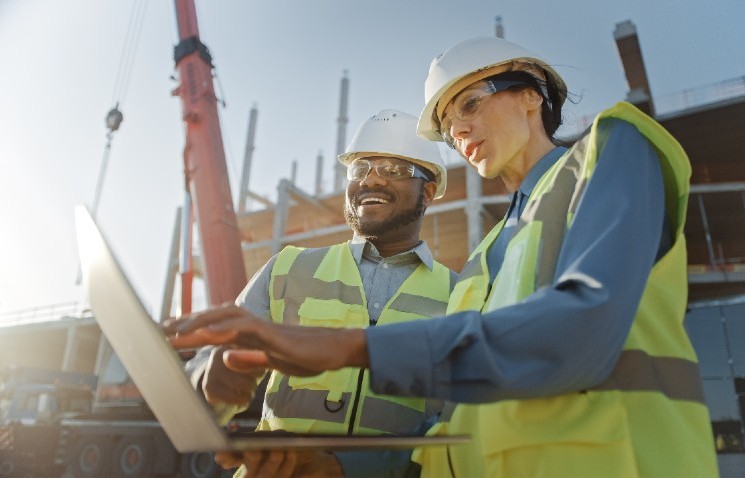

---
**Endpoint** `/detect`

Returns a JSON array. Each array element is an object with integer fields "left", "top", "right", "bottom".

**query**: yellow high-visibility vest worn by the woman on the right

[{"left": 414, "top": 103, "right": 718, "bottom": 478}]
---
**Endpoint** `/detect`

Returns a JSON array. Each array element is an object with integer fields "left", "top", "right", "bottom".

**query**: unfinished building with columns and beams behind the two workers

[{"left": 0, "top": 16, "right": 745, "bottom": 477}]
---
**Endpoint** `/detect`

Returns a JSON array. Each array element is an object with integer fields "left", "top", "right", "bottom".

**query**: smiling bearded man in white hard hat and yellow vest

[{"left": 189, "top": 110, "right": 455, "bottom": 476}]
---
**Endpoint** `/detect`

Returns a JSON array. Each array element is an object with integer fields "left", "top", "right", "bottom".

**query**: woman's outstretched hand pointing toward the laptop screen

[{"left": 163, "top": 305, "right": 369, "bottom": 376}]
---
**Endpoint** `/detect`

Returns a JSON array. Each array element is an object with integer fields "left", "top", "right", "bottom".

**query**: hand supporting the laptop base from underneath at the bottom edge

[{"left": 215, "top": 450, "right": 344, "bottom": 478}]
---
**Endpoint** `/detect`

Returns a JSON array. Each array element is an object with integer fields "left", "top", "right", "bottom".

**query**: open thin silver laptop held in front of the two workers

[{"left": 75, "top": 206, "right": 469, "bottom": 453}]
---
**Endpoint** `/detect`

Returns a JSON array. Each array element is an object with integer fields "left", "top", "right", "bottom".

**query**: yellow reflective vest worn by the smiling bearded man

[{"left": 257, "top": 243, "right": 451, "bottom": 434}]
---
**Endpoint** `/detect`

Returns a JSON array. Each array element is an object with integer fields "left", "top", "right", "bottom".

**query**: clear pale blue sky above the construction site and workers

[{"left": 0, "top": 0, "right": 745, "bottom": 322}]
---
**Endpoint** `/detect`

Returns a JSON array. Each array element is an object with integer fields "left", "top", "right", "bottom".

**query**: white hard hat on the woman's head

[{"left": 417, "top": 37, "right": 566, "bottom": 141}]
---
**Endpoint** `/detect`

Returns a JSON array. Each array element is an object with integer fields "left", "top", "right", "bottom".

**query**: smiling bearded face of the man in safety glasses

[{"left": 344, "top": 156, "right": 436, "bottom": 243}]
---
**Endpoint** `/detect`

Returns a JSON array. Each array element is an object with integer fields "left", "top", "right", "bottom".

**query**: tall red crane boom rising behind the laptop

[{"left": 174, "top": 0, "right": 246, "bottom": 305}]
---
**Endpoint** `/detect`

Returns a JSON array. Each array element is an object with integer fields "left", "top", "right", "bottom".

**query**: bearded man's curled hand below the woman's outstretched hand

[{"left": 202, "top": 346, "right": 265, "bottom": 407}]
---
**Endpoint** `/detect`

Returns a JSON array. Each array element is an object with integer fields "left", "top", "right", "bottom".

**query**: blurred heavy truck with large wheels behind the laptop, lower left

[{"left": 0, "top": 353, "right": 243, "bottom": 478}]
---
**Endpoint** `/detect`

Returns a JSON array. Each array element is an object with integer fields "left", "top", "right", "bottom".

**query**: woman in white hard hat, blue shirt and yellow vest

[{"left": 171, "top": 37, "right": 717, "bottom": 478}]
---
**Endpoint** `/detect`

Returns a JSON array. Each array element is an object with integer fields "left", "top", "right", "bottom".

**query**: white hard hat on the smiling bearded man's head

[{"left": 339, "top": 110, "right": 448, "bottom": 199}]
